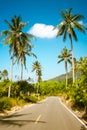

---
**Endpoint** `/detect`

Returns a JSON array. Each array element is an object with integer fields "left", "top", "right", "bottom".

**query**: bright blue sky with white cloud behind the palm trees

[{"left": 0, "top": 0, "right": 87, "bottom": 80}]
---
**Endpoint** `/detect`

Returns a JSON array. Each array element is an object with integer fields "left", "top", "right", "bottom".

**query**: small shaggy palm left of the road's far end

[{"left": 32, "top": 61, "right": 42, "bottom": 94}]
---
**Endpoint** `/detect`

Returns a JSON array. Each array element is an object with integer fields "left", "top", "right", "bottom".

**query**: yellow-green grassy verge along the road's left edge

[{"left": 0, "top": 94, "right": 45, "bottom": 116}]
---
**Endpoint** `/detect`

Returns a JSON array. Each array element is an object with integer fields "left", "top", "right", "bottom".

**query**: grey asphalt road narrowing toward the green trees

[{"left": 0, "top": 97, "right": 86, "bottom": 130}]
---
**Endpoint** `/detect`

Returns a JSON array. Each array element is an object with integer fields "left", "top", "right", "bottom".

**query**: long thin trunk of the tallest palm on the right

[{"left": 69, "top": 35, "right": 75, "bottom": 83}]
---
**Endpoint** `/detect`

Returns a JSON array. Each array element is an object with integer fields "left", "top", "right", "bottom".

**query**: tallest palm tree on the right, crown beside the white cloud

[{"left": 54, "top": 9, "right": 86, "bottom": 82}]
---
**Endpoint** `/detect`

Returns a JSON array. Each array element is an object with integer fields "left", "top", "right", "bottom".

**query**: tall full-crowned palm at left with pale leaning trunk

[{"left": 2, "top": 16, "right": 34, "bottom": 97}]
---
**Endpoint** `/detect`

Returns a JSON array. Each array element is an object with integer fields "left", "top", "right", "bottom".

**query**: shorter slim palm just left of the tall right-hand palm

[{"left": 57, "top": 47, "right": 71, "bottom": 88}]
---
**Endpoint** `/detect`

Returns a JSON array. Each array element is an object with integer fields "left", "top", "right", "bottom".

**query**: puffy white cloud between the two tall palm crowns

[{"left": 29, "top": 23, "right": 58, "bottom": 38}]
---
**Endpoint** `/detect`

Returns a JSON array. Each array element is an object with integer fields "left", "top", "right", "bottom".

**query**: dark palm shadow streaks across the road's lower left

[{"left": 0, "top": 113, "right": 46, "bottom": 127}]
